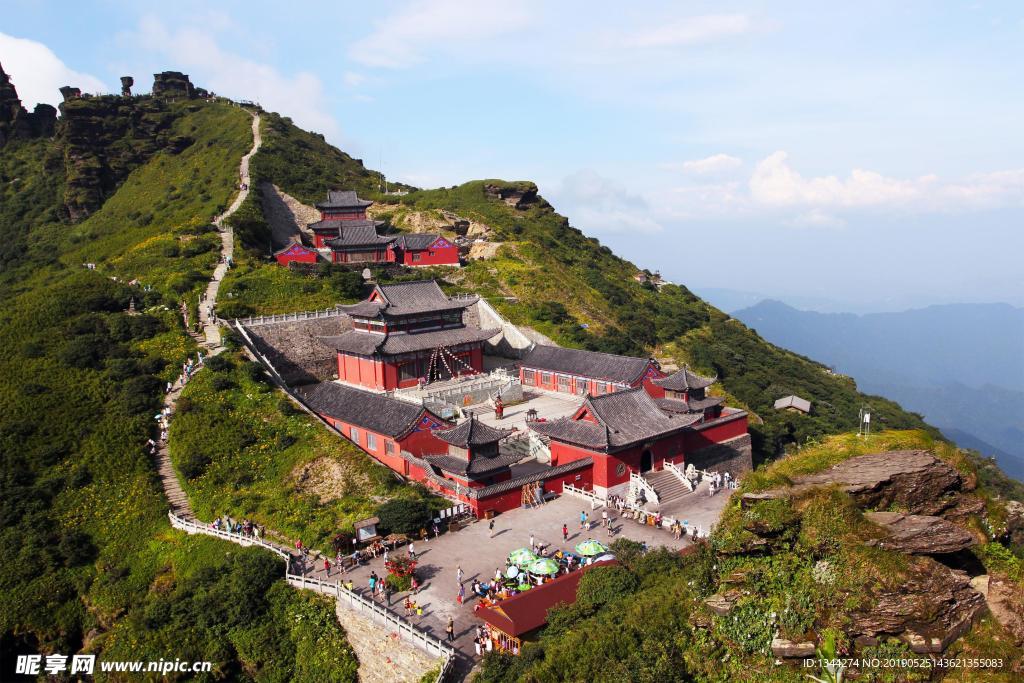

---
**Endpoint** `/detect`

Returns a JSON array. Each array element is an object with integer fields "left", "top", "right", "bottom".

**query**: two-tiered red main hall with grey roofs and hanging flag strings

[{"left": 319, "top": 281, "right": 500, "bottom": 391}]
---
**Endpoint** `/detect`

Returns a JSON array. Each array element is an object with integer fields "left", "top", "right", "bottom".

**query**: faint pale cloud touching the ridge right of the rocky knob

[{"left": 551, "top": 169, "right": 663, "bottom": 233}]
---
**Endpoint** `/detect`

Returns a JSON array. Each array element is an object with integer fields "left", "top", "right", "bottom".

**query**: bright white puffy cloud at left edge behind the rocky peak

[{"left": 0, "top": 33, "right": 109, "bottom": 107}]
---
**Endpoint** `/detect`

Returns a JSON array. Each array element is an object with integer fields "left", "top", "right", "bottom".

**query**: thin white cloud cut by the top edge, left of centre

[{"left": 349, "top": 0, "right": 534, "bottom": 69}]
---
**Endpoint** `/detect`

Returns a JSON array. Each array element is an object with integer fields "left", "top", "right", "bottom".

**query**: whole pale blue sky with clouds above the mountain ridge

[{"left": 0, "top": 0, "right": 1024, "bottom": 310}]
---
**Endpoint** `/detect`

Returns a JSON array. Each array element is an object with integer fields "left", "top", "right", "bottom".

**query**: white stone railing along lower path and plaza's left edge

[{"left": 167, "top": 505, "right": 452, "bottom": 683}]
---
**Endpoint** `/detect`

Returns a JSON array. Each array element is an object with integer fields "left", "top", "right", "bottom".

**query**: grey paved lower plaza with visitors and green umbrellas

[{"left": 296, "top": 488, "right": 728, "bottom": 675}]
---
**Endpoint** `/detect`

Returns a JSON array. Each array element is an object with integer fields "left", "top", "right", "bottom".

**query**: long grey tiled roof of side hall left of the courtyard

[{"left": 295, "top": 382, "right": 444, "bottom": 438}]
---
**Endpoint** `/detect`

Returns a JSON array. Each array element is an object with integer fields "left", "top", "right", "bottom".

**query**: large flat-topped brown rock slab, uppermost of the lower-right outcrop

[{"left": 743, "top": 451, "right": 964, "bottom": 515}]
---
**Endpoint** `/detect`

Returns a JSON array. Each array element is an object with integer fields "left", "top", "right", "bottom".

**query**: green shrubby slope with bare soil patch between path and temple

[{"left": 170, "top": 353, "right": 440, "bottom": 554}]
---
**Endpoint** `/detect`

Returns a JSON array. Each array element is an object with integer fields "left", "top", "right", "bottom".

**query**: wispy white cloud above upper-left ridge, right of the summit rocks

[{"left": 127, "top": 15, "right": 340, "bottom": 142}]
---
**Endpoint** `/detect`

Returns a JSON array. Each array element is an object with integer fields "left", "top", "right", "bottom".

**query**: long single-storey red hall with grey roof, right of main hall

[{"left": 519, "top": 345, "right": 665, "bottom": 398}]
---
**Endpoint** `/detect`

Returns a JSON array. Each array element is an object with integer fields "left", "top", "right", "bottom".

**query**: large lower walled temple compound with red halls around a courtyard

[{"left": 241, "top": 278, "right": 751, "bottom": 516}]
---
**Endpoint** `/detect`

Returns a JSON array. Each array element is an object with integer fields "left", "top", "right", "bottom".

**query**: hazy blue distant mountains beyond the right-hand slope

[{"left": 733, "top": 300, "right": 1024, "bottom": 479}]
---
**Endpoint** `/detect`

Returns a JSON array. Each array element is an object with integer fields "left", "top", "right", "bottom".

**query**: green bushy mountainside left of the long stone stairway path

[{"left": 0, "top": 103, "right": 355, "bottom": 681}]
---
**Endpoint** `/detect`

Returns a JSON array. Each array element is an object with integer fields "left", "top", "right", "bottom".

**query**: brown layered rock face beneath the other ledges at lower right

[{"left": 850, "top": 557, "right": 985, "bottom": 653}]
